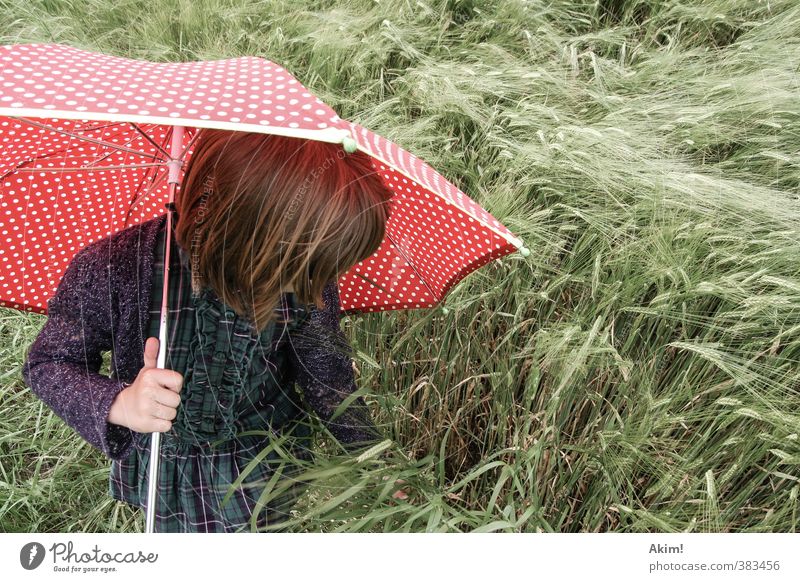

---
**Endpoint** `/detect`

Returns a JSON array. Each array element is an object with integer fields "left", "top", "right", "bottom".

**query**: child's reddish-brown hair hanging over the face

[{"left": 175, "top": 128, "right": 392, "bottom": 332}]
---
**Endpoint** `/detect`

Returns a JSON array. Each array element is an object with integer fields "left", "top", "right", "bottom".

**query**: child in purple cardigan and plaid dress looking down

[{"left": 23, "top": 129, "right": 391, "bottom": 532}]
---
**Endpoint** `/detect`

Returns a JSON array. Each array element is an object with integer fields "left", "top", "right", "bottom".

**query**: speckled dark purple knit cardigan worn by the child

[{"left": 22, "top": 215, "right": 380, "bottom": 460}]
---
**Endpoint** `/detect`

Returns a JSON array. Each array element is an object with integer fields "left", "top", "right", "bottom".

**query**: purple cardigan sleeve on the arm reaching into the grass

[{"left": 289, "top": 281, "right": 381, "bottom": 452}]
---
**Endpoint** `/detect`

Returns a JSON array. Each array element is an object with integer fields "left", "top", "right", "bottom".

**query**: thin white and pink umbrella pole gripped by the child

[{"left": 145, "top": 125, "right": 183, "bottom": 533}]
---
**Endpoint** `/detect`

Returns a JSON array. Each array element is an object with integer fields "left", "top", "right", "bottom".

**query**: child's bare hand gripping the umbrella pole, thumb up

[{"left": 108, "top": 337, "right": 183, "bottom": 433}]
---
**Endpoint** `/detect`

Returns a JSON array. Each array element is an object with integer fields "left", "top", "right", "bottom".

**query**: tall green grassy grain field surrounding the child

[{"left": 0, "top": 0, "right": 800, "bottom": 532}]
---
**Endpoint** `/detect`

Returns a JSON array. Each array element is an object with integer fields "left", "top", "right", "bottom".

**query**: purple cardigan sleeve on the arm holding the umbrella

[{"left": 22, "top": 238, "right": 133, "bottom": 460}]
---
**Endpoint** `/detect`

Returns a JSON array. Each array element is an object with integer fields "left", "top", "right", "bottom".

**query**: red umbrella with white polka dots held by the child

[{"left": 0, "top": 43, "right": 529, "bottom": 531}]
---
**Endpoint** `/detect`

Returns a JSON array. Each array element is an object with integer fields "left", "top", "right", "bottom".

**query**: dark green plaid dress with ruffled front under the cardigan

[{"left": 109, "top": 216, "right": 312, "bottom": 532}]
